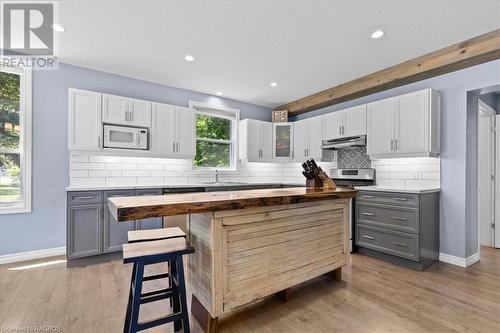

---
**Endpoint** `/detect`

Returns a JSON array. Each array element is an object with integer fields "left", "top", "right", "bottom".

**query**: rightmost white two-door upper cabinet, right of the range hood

[{"left": 367, "top": 89, "right": 440, "bottom": 157}]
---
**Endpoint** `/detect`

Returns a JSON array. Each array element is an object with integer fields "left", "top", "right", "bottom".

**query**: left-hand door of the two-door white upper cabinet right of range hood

[{"left": 366, "top": 98, "right": 397, "bottom": 155}]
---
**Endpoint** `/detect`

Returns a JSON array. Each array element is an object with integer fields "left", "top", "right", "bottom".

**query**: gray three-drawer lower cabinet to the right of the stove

[{"left": 355, "top": 191, "right": 439, "bottom": 270}]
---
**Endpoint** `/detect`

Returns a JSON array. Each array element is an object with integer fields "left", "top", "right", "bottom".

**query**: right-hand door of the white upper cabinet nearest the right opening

[{"left": 394, "top": 90, "right": 429, "bottom": 154}]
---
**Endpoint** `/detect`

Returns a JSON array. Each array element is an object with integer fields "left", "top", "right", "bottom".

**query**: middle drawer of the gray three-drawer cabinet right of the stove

[{"left": 356, "top": 203, "right": 418, "bottom": 233}]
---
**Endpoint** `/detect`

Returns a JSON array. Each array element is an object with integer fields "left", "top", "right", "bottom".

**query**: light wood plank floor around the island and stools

[{"left": 0, "top": 248, "right": 500, "bottom": 333}]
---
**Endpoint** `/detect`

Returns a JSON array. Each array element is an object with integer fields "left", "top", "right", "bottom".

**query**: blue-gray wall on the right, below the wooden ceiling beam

[{"left": 293, "top": 60, "right": 500, "bottom": 258}]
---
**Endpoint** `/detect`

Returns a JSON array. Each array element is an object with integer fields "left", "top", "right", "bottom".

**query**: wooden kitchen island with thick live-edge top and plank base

[{"left": 108, "top": 187, "right": 357, "bottom": 331}]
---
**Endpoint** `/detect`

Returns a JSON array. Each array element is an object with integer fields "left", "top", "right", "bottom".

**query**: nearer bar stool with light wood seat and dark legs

[{"left": 123, "top": 237, "right": 194, "bottom": 333}]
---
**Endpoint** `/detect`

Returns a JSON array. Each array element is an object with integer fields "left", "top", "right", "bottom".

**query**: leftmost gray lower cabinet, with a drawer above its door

[{"left": 66, "top": 192, "right": 103, "bottom": 259}]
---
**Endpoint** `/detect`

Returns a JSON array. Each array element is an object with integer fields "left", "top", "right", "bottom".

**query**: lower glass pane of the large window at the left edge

[{"left": 0, "top": 154, "right": 21, "bottom": 205}]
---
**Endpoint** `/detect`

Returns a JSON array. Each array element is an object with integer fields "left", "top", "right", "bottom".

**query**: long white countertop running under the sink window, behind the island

[{"left": 65, "top": 182, "right": 305, "bottom": 192}]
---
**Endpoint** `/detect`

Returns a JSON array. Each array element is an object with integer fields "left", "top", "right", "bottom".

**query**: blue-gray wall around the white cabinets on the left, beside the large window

[{"left": 0, "top": 64, "right": 271, "bottom": 255}]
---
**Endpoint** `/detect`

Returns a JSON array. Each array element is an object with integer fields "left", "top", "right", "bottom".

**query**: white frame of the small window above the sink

[{"left": 189, "top": 101, "right": 240, "bottom": 173}]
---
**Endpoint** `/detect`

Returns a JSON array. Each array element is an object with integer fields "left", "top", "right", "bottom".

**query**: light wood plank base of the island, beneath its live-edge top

[{"left": 187, "top": 199, "right": 349, "bottom": 332}]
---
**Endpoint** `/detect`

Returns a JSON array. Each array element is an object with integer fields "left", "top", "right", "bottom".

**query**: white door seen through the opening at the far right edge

[{"left": 477, "top": 97, "right": 500, "bottom": 247}]
